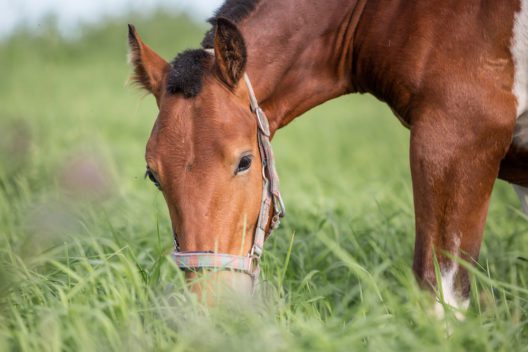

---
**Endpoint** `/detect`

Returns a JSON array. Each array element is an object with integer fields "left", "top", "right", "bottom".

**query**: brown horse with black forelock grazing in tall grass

[{"left": 129, "top": 0, "right": 528, "bottom": 314}]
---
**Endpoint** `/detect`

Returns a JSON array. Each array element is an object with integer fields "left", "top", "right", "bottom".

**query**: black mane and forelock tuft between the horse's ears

[{"left": 167, "top": 0, "right": 260, "bottom": 98}]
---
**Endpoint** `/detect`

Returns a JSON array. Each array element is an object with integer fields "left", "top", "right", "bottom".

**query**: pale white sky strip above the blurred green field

[{"left": 0, "top": 0, "right": 223, "bottom": 37}]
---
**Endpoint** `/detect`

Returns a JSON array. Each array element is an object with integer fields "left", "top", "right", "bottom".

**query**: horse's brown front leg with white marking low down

[{"left": 411, "top": 100, "right": 515, "bottom": 317}]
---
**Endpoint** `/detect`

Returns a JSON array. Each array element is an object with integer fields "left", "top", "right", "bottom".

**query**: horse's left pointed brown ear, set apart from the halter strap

[{"left": 128, "top": 24, "right": 169, "bottom": 101}]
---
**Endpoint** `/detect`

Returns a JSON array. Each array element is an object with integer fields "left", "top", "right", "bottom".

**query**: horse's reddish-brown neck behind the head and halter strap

[{"left": 239, "top": 0, "right": 366, "bottom": 133}]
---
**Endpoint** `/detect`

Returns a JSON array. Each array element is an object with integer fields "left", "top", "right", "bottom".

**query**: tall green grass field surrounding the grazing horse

[{"left": 0, "top": 14, "right": 528, "bottom": 352}]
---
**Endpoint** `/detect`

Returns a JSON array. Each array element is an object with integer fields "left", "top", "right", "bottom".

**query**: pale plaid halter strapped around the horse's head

[{"left": 173, "top": 49, "right": 285, "bottom": 284}]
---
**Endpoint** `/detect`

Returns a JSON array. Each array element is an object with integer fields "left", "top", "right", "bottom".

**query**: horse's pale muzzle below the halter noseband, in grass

[{"left": 186, "top": 271, "right": 253, "bottom": 306}]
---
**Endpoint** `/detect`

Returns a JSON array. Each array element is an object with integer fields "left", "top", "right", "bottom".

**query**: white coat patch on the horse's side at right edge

[{"left": 510, "top": 0, "right": 528, "bottom": 117}]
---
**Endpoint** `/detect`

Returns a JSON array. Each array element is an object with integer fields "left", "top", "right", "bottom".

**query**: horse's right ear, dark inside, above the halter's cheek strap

[{"left": 214, "top": 17, "right": 247, "bottom": 88}]
